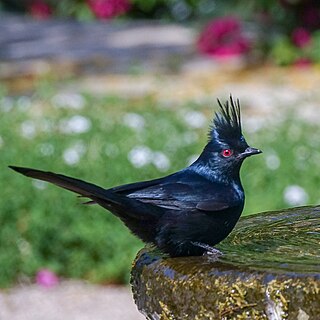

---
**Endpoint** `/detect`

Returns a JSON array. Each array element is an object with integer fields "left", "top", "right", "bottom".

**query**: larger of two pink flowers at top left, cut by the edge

[{"left": 87, "top": 0, "right": 131, "bottom": 19}]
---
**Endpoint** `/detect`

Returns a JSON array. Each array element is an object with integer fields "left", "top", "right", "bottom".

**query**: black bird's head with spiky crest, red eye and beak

[{"left": 192, "top": 96, "right": 262, "bottom": 181}]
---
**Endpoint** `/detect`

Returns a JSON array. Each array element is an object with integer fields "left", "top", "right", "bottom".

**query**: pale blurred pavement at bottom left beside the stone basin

[{"left": 0, "top": 281, "right": 145, "bottom": 320}]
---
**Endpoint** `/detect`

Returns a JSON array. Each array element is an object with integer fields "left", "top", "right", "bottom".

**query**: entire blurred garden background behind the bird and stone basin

[{"left": 0, "top": 0, "right": 320, "bottom": 319}]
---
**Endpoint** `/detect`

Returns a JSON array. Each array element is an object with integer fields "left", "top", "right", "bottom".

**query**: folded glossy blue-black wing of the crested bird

[{"left": 112, "top": 172, "right": 239, "bottom": 212}]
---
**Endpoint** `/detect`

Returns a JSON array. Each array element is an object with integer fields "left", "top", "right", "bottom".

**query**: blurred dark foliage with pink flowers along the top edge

[{"left": 0, "top": 0, "right": 320, "bottom": 66}]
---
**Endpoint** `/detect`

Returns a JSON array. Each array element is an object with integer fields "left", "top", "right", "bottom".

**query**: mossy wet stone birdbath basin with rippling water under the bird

[{"left": 131, "top": 206, "right": 320, "bottom": 320}]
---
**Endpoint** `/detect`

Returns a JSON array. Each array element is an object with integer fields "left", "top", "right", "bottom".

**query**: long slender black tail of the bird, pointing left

[{"left": 9, "top": 166, "right": 155, "bottom": 220}]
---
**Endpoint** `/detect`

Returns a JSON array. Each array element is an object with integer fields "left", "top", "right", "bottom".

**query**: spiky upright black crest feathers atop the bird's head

[{"left": 209, "top": 96, "right": 242, "bottom": 140}]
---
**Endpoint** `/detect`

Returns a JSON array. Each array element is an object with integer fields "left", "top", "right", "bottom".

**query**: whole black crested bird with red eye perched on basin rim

[{"left": 10, "top": 97, "right": 261, "bottom": 257}]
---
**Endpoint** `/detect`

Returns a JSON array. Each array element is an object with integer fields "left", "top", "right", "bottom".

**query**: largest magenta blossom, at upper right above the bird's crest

[{"left": 197, "top": 17, "right": 250, "bottom": 58}]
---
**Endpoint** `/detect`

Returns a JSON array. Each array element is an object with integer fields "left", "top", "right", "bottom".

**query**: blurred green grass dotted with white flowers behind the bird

[{"left": 0, "top": 83, "right": 320, "bottom": 287}]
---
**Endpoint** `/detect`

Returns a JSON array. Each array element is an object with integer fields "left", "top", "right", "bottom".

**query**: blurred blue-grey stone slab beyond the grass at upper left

[{"left": 0, "top": 15, "right": 194, "bottom": 78}]
